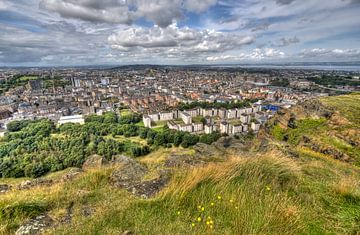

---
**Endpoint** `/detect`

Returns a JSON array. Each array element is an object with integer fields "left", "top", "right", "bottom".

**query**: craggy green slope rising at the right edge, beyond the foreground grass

[{"left": 270, "top": 94, "right": 360, "bottom": 166}]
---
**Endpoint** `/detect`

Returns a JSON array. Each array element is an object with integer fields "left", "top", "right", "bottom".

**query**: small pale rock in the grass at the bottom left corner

[{"left": 15, "top": 215, "right": 54, "bottom": 235}]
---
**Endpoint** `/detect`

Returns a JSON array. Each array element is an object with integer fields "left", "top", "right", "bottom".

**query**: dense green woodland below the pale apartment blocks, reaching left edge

[{"left": 0, "top": 112, "right": 220, "bottom": 177}]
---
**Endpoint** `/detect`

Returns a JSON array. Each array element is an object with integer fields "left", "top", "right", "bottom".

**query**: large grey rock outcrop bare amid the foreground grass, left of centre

[{"left": 110, "top": 156, "right": 169, "bottom": 198}]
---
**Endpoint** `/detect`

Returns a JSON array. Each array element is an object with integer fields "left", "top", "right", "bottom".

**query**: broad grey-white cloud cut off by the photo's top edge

[{"left": 40, "top": 0, "right": 217, "bottom": 27}]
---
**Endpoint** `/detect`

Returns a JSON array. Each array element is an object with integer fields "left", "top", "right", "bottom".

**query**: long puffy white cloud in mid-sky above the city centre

[{"left": 108, "top": 24, "right": 255, "bottom": 52}]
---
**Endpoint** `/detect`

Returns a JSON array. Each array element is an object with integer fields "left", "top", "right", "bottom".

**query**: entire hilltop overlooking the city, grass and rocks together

[{"left": 0, "top": 94, "right": 360, "bottom": 234}]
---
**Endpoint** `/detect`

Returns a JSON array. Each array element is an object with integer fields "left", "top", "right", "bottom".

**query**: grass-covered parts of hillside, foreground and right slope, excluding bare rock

[{"left": 0, "top": 96, "right": 360, "bottom": 234}]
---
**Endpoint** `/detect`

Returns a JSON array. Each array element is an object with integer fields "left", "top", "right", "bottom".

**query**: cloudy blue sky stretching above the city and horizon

[{"left": 0, "top": 0, "right": 360, "bottom": 66}]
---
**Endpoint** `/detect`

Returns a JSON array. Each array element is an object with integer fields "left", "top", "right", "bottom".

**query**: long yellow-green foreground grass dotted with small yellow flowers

[{"left": 0, "top": 149, "right": 360, "bottom": 234}]
